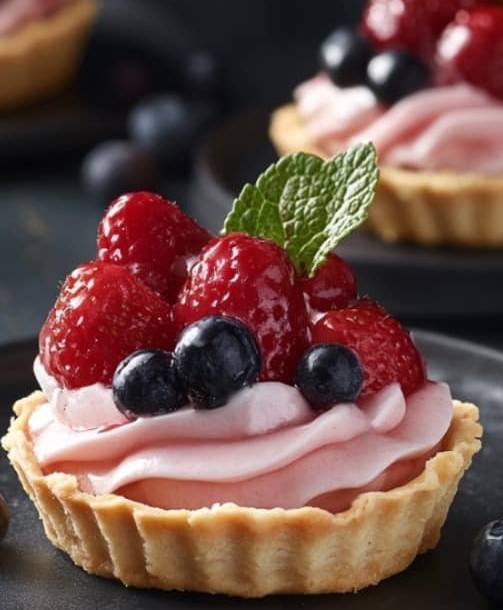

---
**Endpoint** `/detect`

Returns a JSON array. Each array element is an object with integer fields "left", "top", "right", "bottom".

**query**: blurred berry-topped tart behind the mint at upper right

[{"left": 270, "top": 0, "right": 503, "bottom": 248}]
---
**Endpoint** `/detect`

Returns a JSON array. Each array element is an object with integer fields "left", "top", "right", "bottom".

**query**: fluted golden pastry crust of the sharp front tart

[{"left": 2, "top": 392, "right": 482, "bottom": 597}]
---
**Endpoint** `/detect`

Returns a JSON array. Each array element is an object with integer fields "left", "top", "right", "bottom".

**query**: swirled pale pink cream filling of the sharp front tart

[{"left": 29, "top": 361, "right": 452, "bottom": 512}]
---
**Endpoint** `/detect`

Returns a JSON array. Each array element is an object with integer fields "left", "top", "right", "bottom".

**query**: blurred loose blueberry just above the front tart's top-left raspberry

[{"left": 81, "top": 140, "right": 158, "bottom": 203}]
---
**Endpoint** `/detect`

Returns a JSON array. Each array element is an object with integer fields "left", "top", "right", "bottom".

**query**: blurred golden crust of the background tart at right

[{"left": 270, "top": 104, "right": 503, "bottom": 248}]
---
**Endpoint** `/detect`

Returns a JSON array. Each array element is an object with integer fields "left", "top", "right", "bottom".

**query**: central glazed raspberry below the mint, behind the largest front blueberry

[{"left": 175, "top": 233, "right": 307, "bottom": 382}]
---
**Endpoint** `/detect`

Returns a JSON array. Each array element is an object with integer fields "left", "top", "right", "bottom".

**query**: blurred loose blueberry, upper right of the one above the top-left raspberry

[{"left": 128, "top": 94, "right": 213, "bottom": 166}]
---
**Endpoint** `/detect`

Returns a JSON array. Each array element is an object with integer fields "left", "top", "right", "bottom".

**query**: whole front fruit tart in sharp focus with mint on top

[{"left": 2, "top": 145, "right": 482, "bottom": 597}]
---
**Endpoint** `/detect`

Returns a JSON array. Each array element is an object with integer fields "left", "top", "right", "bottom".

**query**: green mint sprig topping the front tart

[{"left": 223, "top": 144, "right": 379, "bottom": 276}]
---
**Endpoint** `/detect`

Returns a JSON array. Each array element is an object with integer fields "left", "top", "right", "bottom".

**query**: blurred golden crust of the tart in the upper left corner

[{"left": 0, "top": 0, "right": 97, "bottom": 110}]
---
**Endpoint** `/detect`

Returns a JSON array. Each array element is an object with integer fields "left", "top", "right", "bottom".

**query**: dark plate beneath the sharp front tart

[{"left": 0, "top": 332, "right": 503, "bottom": 610}]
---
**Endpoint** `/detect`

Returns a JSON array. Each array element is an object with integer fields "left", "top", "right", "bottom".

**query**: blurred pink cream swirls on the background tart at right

[{"left": 295, "top": 74, "right": 503, "bottom": 175}]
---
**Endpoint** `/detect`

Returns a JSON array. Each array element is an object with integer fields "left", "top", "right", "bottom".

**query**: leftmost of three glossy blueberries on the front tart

[{"left": 112, "top": 350, "right": 187, "bottom": 417}]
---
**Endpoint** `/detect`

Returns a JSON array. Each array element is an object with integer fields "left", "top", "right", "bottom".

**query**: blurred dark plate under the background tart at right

[{"left": 193, "top": 110, "right": 503, "bottom": 318}]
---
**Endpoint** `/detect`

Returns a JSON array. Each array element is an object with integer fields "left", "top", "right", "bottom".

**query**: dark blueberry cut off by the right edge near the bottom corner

[{"left": 470, "top": 519, "right": 503, "bottom": 603}]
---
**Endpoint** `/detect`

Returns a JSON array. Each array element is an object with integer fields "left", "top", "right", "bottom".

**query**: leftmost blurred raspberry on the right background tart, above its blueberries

[{"left": 362, "top": 0, "right": 476, "bottom": 61}]
